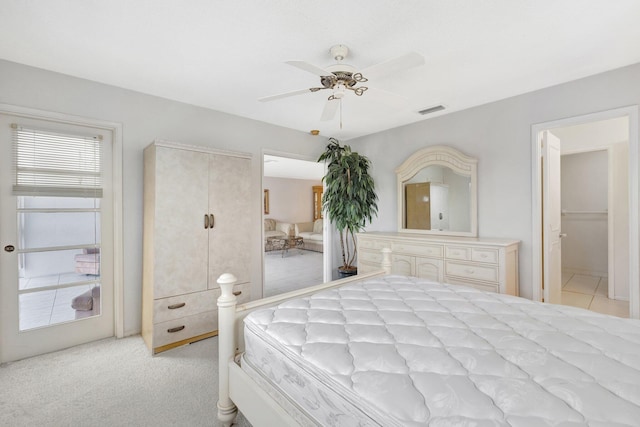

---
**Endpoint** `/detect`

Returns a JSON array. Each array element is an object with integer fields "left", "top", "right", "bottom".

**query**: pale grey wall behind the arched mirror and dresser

[{"left": 350, "top": 64, "right": 640, "bottom": 298}]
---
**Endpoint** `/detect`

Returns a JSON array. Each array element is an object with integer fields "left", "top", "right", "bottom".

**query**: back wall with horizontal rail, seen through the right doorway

[{"left": 560, "top": 151, "right": 609, "bottom": 276}]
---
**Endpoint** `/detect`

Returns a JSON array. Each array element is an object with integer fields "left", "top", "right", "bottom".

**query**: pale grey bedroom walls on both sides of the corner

[{"left": 0, "top": 60, "right": 640, "bottom": 328}]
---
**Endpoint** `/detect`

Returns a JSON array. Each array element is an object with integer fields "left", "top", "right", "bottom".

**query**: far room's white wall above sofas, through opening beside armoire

[{"left": 262, "top": 177, "right": 322, "bottom": 224}]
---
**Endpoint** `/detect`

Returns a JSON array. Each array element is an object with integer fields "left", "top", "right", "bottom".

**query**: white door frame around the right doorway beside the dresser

[{"left": 531, "top": 105, "right": 640, "bottom": 319}]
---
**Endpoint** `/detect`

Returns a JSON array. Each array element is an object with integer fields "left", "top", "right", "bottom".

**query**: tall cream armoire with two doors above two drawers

[{"left": 142, "top": 141, "right": 251, "bottom": 353}]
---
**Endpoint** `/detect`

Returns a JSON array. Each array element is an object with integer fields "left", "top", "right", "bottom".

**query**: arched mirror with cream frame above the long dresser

[{"left": 396, "top": 146, "right": 478, "bottom": 237}]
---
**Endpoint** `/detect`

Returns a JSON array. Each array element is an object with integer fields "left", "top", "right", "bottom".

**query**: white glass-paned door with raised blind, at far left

[{"left": 0, "top": 114, "right": 114, "bottom": 362}]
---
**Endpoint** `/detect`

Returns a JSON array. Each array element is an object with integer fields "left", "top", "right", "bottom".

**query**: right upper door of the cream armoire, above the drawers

[{"left": 208, "top": 154, "right": 252, "bottom": 289}]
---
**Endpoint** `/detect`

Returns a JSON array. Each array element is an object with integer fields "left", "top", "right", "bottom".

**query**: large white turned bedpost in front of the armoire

[{"left": 218, "top": 273, "right": 238, "bottom": 427}]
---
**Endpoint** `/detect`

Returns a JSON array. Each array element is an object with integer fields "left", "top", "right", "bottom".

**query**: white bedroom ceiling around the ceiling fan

[{"left": 0, "top": 0, "right": 640, "bottom": 140}]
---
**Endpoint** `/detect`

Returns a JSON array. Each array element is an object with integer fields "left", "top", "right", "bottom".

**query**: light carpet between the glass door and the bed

[{"left": 0, "top": 336, "right": 251, "bottom": 427}]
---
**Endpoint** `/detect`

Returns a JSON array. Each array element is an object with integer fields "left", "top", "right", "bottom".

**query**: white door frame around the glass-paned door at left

[{"left": 0, "top": 104, "right": 124, "bottom": 338}]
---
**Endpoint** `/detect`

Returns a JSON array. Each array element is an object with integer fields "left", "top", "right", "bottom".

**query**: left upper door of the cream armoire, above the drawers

[{"left": 152, "top": 147, "right": 209, "bottom": 298}]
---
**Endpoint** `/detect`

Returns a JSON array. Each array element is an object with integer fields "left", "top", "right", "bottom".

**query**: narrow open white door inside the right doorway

[{"left": 541, "top": 131, "right": 562, "bottom": 304}]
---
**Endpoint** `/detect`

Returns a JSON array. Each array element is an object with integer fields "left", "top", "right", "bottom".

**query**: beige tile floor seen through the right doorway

[{"left": 562, "top": 273, "right": 629, "bottom": 318}]
